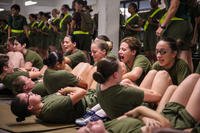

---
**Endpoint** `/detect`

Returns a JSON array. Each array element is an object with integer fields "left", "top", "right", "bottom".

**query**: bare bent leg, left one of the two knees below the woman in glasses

[{"left": 139, "top": 70, "right": 157, "bottom": 89}]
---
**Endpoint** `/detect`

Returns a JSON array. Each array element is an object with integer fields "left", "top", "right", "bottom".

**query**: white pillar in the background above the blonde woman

[{"left": 97, "top": 0, "right": 120, "bottom": 53}]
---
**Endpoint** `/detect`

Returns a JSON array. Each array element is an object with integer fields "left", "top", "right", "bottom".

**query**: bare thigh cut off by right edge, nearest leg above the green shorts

[{"left": 186, "top": 78, "right": 200, "bottom": 121}]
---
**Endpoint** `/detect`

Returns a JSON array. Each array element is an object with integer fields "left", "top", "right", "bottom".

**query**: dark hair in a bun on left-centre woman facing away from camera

[{"left": 43, "top": 52, "right": 63, "bottom": 67}]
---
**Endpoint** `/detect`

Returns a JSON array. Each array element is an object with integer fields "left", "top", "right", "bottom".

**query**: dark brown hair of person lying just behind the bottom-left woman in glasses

[{"left": 12, "top": 76, "right": 25, "bottom": 95}]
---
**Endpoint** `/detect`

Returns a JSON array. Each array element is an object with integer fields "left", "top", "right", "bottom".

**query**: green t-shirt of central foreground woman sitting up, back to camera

[{"left": 97, "top": 84, "right": 144, "bottom": 119}]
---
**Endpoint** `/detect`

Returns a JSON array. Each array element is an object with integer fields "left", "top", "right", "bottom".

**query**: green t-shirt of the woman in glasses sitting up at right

[{"left": 152, "top": 59, "right": 191, "bottom": 85}]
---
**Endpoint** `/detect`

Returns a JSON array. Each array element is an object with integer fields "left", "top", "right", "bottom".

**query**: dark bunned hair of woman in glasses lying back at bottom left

[{"left": 10, "top": 97, "right": 31, "bottom": 122}]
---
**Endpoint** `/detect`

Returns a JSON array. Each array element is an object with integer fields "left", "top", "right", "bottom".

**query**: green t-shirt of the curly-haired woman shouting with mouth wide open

[{"left": 126, "top": 55, "right": 151, "bottom": 85}]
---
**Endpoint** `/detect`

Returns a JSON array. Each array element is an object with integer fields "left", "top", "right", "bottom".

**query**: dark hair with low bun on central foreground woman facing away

[{"left": 93, "top": 57, "right": 119, "bottom": 83}]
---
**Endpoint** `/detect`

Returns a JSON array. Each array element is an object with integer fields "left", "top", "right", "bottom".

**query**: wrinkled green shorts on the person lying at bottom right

[{"left": 162, "top": 102, "right": 197, "bottom": 129}]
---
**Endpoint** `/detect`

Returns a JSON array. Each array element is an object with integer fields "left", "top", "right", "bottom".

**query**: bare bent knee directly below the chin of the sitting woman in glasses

[{"left": 151, "top": 71, "right": 172, "bottom": 96}]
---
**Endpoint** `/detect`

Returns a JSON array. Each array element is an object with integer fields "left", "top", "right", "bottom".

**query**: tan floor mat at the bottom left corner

[{"left": 0, "top": 103, "right": 76, "bottom": 133}]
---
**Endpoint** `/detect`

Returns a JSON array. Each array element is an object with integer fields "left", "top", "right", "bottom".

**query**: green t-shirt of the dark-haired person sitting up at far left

[{"left": 24, "top": 49, "right": 44, "bottom": 69}]
